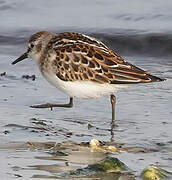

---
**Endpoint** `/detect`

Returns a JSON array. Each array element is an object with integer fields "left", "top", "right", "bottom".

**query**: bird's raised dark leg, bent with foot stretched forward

[{"left": 30, "top": 97, "right": 73, "bottom": 110}]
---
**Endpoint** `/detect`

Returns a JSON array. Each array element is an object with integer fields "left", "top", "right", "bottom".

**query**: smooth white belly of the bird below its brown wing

[{"left": 43, "top": 72, "right": 128, "bottom": 98}]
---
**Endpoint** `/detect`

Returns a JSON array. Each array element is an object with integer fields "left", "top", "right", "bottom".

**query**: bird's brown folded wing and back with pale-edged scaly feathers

[{"left": 50, "top": 33, "right": 164, "bottom": 84}]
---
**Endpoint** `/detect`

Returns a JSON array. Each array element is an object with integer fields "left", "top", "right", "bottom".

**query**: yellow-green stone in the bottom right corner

[{"left": 141, "top": 165, "right": 172, "bottom": 180}]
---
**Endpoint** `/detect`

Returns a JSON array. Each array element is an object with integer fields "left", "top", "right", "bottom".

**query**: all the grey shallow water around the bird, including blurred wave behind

[{"left": 0, "top": 0, "right": 172, "bottom": 179}]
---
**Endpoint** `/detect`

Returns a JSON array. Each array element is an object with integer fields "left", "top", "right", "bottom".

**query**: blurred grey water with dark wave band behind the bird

[{"left": 0, "top": 0, "right": 172, "bottom": 56}]
